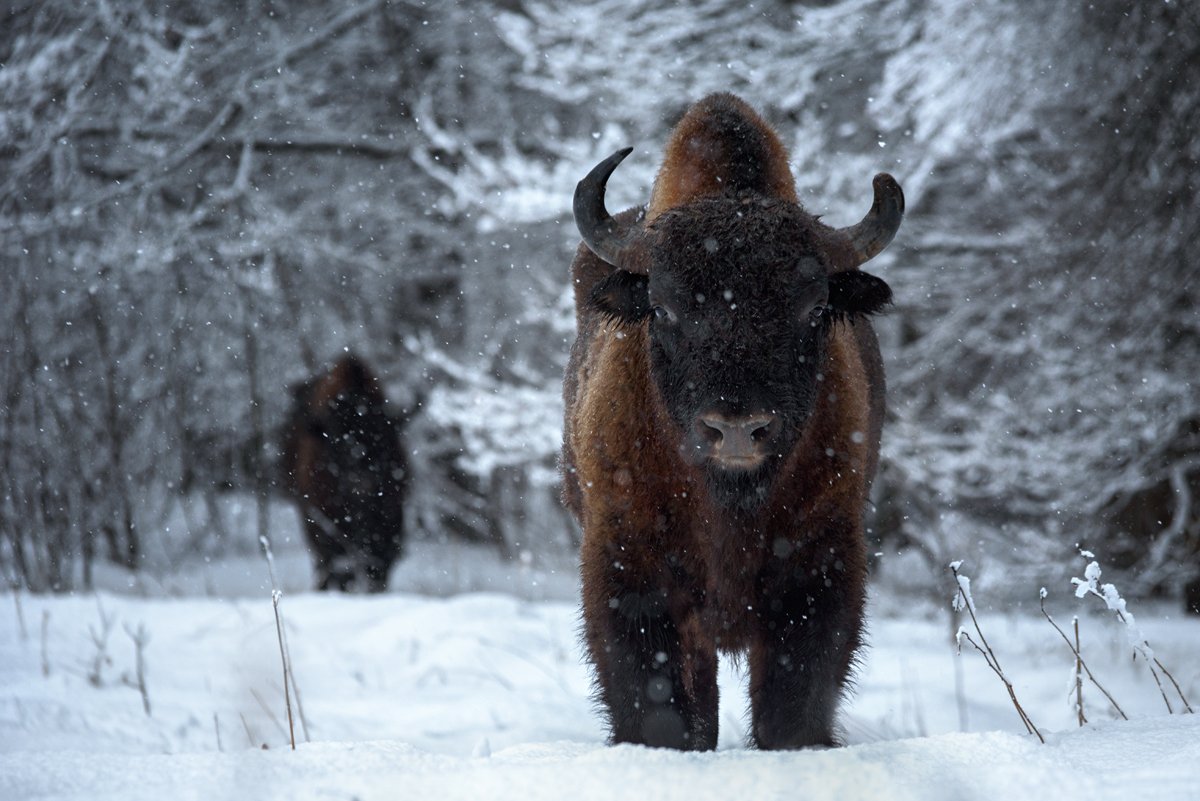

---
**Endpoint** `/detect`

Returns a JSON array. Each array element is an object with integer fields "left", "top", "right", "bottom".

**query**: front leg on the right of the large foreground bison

[{"left": 750, "top": 537, "right": 864, "bottom": 749}]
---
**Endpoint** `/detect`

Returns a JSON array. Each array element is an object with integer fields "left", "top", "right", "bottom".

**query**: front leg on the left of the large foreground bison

[{"left": 583, "top": 551, "right": 718, "bottom": 751}]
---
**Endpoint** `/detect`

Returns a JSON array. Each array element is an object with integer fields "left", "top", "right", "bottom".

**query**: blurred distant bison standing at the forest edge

[{"left": 282, "top": 355, "right": 408, "bottom": 592}]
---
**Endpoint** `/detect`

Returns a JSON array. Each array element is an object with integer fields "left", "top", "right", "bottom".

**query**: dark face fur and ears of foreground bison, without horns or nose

[{"left": 592, "top": 193, "right": 892, "bottom": 512}]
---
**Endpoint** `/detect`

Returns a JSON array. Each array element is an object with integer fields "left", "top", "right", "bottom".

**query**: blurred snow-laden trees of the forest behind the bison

[{"left": 0, "top": 0, "right": 1200, "bottom": 597}]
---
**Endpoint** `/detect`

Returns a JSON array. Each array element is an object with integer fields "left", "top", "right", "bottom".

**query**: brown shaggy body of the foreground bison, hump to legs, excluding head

[{"left": 563, "top": 95, "right": 883, "bottom": 748}]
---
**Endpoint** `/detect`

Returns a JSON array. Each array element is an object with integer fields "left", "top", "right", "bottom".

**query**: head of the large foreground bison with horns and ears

[{"left": 575, "top": 150, "right": 904, "bottom": 511}]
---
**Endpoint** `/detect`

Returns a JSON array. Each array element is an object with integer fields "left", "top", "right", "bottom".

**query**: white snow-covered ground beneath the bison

[{"left": 0, "top": 515, "right": 1200, "bottom": 801}]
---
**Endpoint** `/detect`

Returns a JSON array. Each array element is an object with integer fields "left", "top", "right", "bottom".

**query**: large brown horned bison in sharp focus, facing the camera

[{"left": 563, "top": 95, "right": 904, "bottom": 749}]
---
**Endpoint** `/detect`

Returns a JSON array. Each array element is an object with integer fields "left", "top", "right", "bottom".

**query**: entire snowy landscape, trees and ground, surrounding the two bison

[{"left": 0, "top": 0, "right": 1200, "bottom": 801}]
